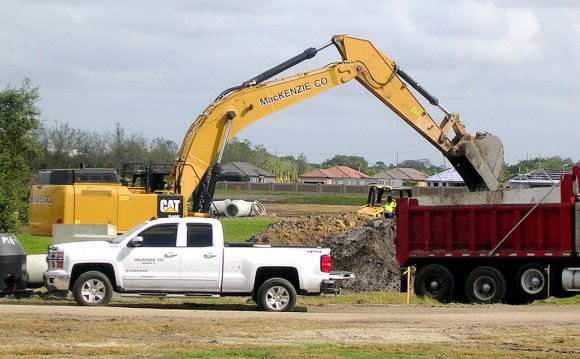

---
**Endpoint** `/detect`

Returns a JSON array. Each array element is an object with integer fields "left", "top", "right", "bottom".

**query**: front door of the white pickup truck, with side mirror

[{"left": 122, "top": 224, "right": 180, "bottom": 291}]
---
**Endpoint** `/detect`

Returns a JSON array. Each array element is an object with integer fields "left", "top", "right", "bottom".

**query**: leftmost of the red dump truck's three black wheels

[{"left": 413, "top": 264, "right": 455, "bottom": 303}]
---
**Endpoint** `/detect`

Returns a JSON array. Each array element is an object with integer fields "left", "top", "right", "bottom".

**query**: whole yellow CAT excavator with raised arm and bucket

[{"left": 29, "top": 35, "right": 503, "bottom": 235}]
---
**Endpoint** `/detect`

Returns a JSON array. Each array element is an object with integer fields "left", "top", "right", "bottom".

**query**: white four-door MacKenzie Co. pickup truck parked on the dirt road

[{"left": 43, "top": 218, "right": 344, "bottom": 311}]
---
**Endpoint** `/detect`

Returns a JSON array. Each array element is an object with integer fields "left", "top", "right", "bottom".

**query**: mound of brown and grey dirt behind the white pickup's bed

[{"left": 251, "top": 213, "right": 399, "bottom": 291}]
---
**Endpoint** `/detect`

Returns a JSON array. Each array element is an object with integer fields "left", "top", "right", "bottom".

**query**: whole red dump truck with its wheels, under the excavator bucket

[{"left": 396, "top": 166, "right": 580, "bottom": 303}]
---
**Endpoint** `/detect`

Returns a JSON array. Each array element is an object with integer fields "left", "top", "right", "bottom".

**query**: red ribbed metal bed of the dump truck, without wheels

[{"left": 396, "top": 175, "right": 575, "bottom": 266}]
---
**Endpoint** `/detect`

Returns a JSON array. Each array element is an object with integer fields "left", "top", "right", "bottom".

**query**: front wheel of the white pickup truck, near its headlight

[{"left": 73, "top": 271, "right": 113, "bottom": 306}]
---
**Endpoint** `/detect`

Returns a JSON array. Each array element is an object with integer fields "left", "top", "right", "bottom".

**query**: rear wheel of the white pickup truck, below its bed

[{"left": 256, "top": 278, "right": 296, "bottom": 312}]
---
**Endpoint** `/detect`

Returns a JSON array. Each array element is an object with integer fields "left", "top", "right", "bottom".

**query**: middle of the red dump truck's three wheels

[{"left": 465, "top": 267, "right": 507, "bottom": 304}]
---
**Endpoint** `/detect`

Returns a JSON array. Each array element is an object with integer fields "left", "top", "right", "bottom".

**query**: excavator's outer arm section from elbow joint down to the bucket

[{"left": 332, "top": 35, "right": 504, "bottom": 191}]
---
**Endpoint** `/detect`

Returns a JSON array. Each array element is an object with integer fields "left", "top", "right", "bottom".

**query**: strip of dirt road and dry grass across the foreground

[{"left": 0, "top": 302, "right": 580, "bottom": 358}]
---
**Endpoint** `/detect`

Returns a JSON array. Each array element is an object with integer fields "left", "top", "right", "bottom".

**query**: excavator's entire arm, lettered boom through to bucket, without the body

[{"left": 168, "top": 35, "right": 503, "bottom": 212}]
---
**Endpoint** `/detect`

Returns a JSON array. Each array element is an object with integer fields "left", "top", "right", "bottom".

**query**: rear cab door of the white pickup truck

[{"left": 179, "top": 223, "right": 223, "bottom": 293}]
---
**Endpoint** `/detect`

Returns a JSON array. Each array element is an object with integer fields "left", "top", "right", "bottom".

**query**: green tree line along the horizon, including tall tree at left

[{"left": 0, "top": 79, "right": 579, "bottom": 232}]
